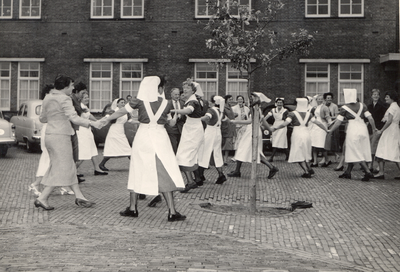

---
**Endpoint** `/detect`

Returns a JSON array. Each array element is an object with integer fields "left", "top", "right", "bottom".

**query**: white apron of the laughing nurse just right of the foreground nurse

[{"left": 176, "top": 116, "right": 204, "bottom": 167}]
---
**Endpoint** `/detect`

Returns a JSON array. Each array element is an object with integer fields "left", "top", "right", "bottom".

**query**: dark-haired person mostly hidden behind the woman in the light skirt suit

[{"left": 71, "top": 82, "right": 87, "bottom": 182}]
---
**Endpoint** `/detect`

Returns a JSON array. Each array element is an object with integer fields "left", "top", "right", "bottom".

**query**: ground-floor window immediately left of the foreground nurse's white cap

[{"left": 120, "top": 63, "right": 143, "bottom": 98}]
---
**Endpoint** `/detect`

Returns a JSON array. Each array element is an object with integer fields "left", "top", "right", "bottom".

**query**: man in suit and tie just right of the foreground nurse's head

[{"left": 165, "top": 88, "right": 186, "bottom": 154}]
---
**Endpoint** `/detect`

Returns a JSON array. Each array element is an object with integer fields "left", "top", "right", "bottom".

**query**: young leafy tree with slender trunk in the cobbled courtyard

[{"left": 205, "top": 0, "right": 314, "bottom": 214}]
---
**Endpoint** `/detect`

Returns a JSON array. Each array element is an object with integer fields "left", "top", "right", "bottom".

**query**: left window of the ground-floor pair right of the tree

[{"left": 305, "top": 63, "right": 330, "bottom": 96}]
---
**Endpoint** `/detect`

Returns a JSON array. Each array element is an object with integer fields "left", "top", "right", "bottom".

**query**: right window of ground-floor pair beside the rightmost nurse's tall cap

[{"left": 338, "top": 63, "right": 364, "bottom": 104}]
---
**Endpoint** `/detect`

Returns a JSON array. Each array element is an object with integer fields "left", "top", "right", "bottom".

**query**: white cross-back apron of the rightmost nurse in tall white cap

[{"left": 342, "top": 103, "right": 372, "bottom": 163}]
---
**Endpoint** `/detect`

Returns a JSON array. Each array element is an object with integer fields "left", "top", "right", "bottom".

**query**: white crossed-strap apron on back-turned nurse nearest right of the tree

[{"left": 288, "top": 111, "right": 311, "bottom": 163}]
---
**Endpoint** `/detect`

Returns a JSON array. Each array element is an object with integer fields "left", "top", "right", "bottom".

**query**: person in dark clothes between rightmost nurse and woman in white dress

[{"left": 367, "top": 89, "right": 388, "bottom": 173}]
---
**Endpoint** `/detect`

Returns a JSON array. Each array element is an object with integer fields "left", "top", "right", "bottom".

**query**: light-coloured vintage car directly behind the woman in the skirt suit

[{"left": 10, "top": 100, "right": 43, "bottom": 151}]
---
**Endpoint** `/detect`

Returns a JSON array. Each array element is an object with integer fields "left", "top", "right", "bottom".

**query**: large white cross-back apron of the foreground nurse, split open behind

[{"left": 128, "top": 99, "right": 185, "bottom": 195}]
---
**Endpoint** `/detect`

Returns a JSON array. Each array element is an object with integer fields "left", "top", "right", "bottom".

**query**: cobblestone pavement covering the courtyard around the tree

[{"left": 0, "top": 147, "right": 400, "bottom": 272}]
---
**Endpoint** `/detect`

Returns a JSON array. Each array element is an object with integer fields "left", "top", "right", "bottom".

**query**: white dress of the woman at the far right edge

[{"left": 375, "top": 102, "right": 400, "bottom": 162}]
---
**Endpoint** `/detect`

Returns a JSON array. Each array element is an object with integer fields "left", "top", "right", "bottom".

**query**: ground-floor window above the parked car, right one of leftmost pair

[{"left": 18, "top": 62, "right": 40, "bottom": 105}]
